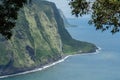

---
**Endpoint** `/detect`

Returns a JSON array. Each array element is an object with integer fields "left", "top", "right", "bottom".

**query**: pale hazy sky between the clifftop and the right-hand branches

[{"left": 48, "top": 0, "right": 74, "bottom": 18}]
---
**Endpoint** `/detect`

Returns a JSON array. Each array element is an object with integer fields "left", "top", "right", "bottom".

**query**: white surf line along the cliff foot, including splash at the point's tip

[{"left": 0, "top": 47, "right": 101, "bottom": 79}]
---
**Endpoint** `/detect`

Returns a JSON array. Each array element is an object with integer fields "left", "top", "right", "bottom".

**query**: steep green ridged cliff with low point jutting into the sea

[{"left": 0, "top": 0, "right": 96, "bottom": 75}]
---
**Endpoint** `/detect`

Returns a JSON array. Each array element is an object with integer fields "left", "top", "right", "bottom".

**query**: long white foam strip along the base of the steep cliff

[{"left": 0, "top": 55, "right": 71, "bottom": 78}]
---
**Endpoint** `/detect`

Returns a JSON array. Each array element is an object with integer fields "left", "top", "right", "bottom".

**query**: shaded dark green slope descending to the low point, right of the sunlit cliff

[{"left": 49, "top": 4, "right": 97, "bottom": 54}]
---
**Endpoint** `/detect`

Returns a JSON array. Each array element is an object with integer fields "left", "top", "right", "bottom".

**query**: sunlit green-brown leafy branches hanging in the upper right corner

[{"left": 69, "top": 0, "right": 120, "bottom": 33}]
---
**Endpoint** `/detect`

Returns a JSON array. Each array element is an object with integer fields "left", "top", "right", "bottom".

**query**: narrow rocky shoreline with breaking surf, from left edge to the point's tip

[{"left": 0, "top": 47, "right": 101, "bottom": 78}]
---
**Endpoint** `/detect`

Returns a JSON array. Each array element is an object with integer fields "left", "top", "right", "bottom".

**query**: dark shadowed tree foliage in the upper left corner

[{"left": 0, "top": 0, "right": 27, "bottom": 39}]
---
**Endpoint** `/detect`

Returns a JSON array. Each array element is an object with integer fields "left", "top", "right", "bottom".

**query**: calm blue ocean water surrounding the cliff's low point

[{"left": 0, "top": 18, "right": 120, "bottom": 80}]
